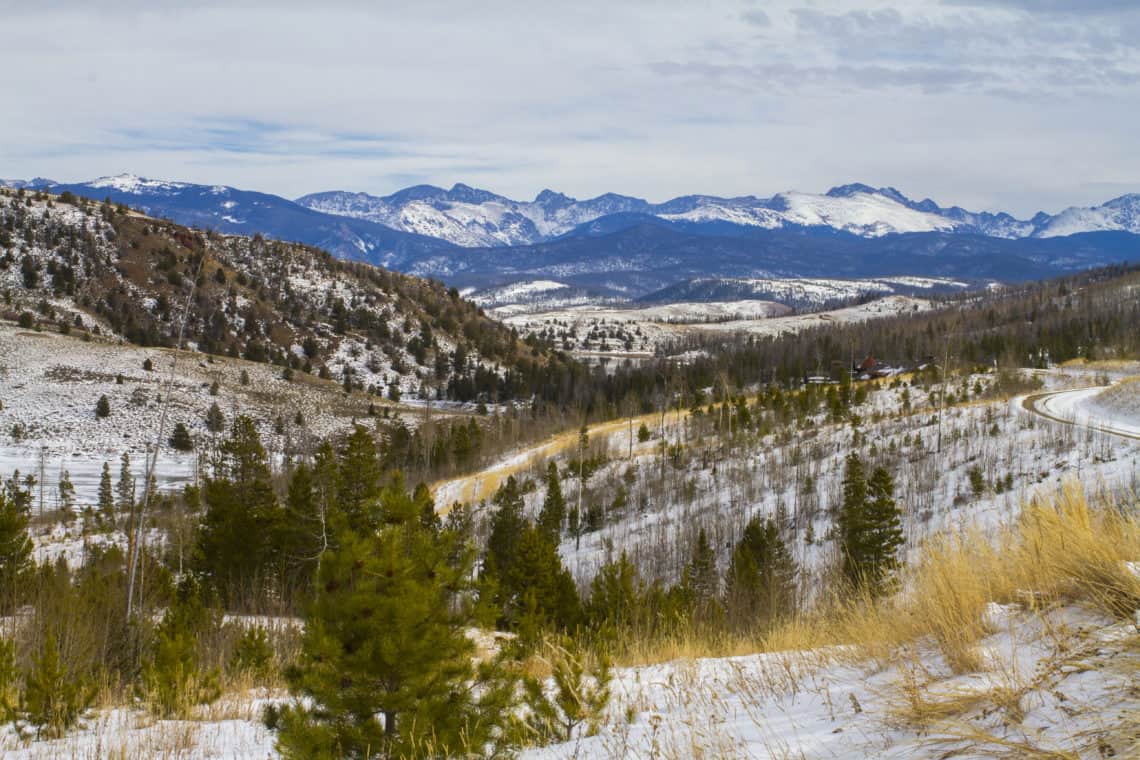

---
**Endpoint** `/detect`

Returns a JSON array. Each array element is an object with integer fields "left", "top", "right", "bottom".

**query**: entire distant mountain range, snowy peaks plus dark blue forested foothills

[{"left": 8, "top": 174, "right": 1140, "bottom": 297}]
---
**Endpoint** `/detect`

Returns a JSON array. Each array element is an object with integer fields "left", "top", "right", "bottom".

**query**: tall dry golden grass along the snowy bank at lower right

[{"left": 629, "top": 483, "right": 1140, "bottom": 688}]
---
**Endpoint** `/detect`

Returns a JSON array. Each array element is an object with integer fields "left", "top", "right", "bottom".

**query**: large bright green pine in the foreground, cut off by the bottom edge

[{"left": 277, "top": 489, "right": 514, "bottom": 759}]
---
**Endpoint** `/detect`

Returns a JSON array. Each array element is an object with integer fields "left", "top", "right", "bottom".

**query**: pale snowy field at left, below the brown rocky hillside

[{"left": 0, "top": 324, "right": 419, "bottom": 509}]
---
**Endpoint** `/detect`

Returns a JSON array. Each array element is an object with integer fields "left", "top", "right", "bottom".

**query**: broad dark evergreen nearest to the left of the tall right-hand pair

[{"left": 725, "top": 517, "right": 796, "bottom": 628}]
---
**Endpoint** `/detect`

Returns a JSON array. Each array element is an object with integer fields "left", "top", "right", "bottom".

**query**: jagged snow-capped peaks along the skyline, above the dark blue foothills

[{"left": 296, "top": 183, "right": 1140, "bottom": 247}]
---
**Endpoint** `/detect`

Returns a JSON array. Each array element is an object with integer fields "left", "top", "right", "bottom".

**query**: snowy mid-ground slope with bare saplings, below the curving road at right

[{"left": 435, "top": 369, "right": 1140, "bottom": 590}]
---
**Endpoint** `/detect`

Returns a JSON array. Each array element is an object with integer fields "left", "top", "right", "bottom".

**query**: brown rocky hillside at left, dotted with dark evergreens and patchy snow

[{"left": 0, "top": 190, "right": 562, "bottom": 402}]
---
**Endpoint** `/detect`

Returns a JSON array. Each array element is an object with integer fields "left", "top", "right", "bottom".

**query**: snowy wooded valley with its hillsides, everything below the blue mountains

[{"left": 0, "top": 191, "right": 1140, "bottom": 759}]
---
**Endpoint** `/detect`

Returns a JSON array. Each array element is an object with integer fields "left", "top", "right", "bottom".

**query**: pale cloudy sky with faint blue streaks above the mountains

[{"left": 0, "top": 0, "right": 1140, "bottom": 216}]
